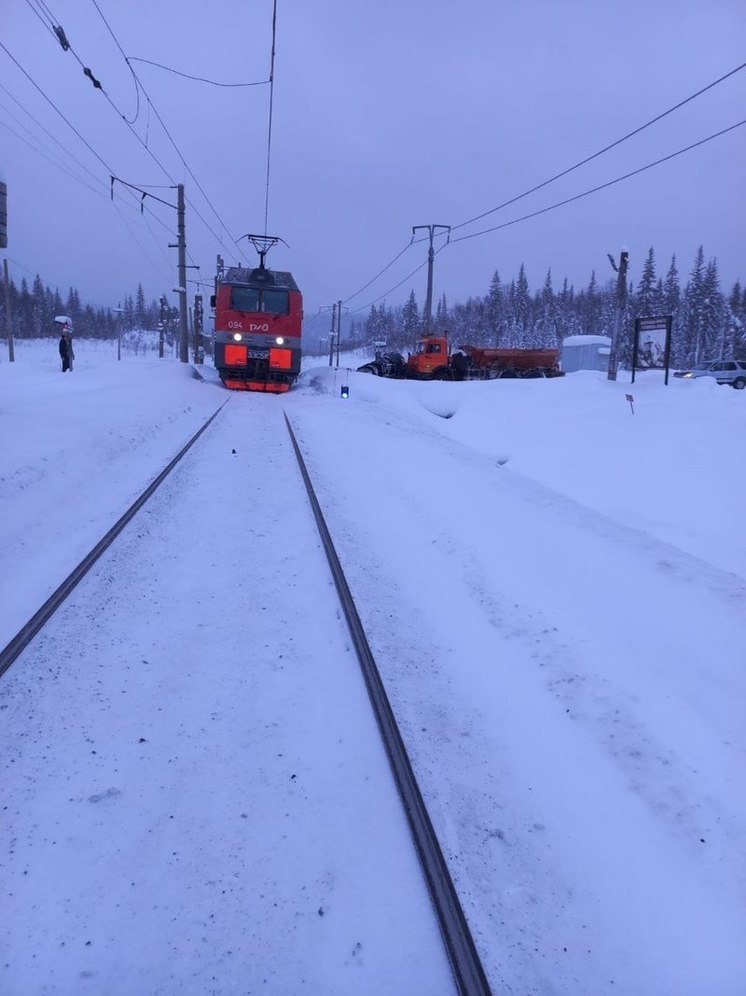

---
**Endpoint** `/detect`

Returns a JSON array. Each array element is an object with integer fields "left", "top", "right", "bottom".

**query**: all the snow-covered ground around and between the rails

[{"left": 0, "top": 340, "right": 746, "bottom": 996}]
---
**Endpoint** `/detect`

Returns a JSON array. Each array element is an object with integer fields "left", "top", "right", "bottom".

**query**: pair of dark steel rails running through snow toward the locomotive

[{"left": 0, "top": 402, "right": 491, "bottom": 996}]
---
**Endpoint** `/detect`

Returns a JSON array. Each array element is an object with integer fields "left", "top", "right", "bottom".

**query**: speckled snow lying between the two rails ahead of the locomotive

[{"left": 0, "top": 396, "right": 453, "bottom": 996}]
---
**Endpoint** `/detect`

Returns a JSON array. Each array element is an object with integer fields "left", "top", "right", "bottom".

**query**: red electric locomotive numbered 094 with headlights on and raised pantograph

[{"left": 211, "top": 236, "right": 303, "bottom": 394}]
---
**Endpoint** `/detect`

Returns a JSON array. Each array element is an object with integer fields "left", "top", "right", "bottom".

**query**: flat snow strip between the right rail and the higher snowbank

[{"left": 293, "top": 374, "right": 746, "bottom": 996}]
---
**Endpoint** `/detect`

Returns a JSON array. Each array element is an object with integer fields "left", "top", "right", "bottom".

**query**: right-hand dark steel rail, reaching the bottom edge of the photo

[{"left": 285, "top": 414, "right": 491, "bottom": 996}]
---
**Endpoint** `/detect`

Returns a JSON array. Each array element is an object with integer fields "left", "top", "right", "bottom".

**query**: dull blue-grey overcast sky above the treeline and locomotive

[{"left": 0, "top": 0, "right": 746, "bottom": 336}]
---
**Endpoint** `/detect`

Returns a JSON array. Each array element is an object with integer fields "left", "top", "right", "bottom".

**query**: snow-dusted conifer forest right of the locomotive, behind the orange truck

[{"left": 351, "top": 246, "right": 746, "bottom": 366}]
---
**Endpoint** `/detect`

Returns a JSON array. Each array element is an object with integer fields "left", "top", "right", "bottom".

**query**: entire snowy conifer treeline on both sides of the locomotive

[{"left": 0, "top": 246, "right": 746, "bottom": 366}]
